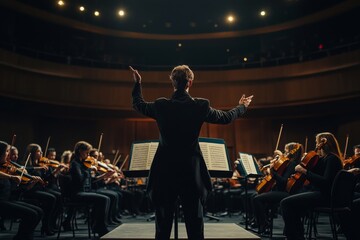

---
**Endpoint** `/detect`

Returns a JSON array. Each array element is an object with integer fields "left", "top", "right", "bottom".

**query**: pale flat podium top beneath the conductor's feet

[{"left": 101, "top": 223, "right": 260, "bottom": 240}]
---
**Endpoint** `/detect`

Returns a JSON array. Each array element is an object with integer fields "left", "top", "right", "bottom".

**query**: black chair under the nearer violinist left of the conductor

[{"left": 57, "top": 174, "right": 93, "bottom": 239}]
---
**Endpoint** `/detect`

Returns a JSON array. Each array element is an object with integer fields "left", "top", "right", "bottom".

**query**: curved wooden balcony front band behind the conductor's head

[{"left": 0, "top": 50, "right": 360, "bottom": 110}]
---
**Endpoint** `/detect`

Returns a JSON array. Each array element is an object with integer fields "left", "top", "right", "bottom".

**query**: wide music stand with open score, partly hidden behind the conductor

[{"left": 124, "top": 138, "right": 232, "bottom": 239}]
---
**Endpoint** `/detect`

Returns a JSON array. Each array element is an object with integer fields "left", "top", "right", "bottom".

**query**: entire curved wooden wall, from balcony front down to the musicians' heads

[{"left": 0, "top": 50, "right": 360, "bottom": 160}]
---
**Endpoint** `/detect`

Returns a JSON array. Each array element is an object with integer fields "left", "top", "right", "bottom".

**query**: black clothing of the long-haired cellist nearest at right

[{"left": 280, "top": 153, "right": 343, "bottom": 240}]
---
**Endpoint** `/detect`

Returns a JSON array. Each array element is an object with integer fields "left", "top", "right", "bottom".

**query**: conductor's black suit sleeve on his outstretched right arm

[{"left": 205, "top": 101, "right": 246, "bottom": 124}]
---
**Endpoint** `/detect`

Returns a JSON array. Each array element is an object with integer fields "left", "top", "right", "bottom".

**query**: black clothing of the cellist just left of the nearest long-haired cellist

[{"left": 253, "top": 161, "right": 299, "bottom": 233}]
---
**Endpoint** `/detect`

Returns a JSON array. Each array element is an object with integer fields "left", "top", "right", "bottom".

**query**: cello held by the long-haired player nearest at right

[{"left": 286, "top": 138, "right": 327, "bottom": 194}]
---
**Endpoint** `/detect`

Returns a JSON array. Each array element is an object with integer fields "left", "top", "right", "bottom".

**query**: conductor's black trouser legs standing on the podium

[{"left": 155, "top": 189, "right": 204, "bottom": 240}]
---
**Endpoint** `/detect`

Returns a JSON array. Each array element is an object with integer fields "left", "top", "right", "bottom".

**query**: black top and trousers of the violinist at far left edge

[{"left": 0, "top": 176, "right": 43, "bottom": 240}]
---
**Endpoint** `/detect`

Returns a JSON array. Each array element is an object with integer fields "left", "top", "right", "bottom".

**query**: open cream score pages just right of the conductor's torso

[{"left": 199, "top": 142, "right": 229, "bottom": 171}]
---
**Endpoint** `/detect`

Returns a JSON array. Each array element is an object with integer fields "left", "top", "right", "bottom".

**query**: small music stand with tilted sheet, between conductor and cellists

[{"left": 237, "top": 152, "right": 263, "bottom": 230}]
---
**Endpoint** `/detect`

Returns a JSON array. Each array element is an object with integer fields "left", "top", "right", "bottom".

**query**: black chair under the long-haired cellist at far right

[{"left": 309, "top": 170, "right": 355, "bottom": 239}]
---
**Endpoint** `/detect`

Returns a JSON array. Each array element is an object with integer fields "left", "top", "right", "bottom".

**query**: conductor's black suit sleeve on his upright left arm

[{"left": 132, "top": 83, "right": 155, "bottom": 118}]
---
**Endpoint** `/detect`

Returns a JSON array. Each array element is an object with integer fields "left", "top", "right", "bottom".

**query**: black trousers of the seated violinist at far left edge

[{"left": 0, "top": 201, "right": 43, "bottom": 240}]
